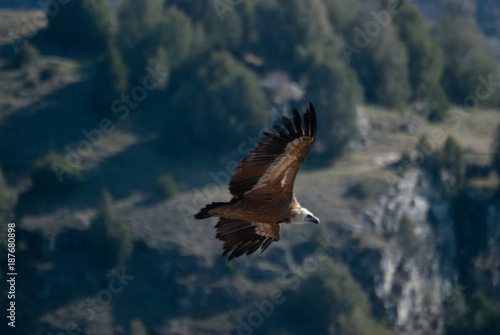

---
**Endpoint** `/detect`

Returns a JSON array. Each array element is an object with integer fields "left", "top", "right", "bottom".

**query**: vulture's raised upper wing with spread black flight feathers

[{"left": 229, "top": 103, "right": 316, "bottom": 197}]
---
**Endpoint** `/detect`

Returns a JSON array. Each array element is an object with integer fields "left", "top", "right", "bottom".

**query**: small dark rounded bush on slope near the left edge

[{"left": 31, "top": 154, "right": 82, "bottom": 197}]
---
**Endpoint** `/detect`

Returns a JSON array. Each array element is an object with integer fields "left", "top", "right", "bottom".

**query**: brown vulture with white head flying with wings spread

[{"left": 195, "top": 103, "right": 319, "bottom": 261}]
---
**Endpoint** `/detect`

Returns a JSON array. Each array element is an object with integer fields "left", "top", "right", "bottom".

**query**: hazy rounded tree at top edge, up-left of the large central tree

[{"left": 116, "top": 0, "right": 198, "bottom": 84}]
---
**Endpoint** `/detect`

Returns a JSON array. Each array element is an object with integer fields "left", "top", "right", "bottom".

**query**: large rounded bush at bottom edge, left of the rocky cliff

[{"left": 276, "top": 259, "right": 392, "bottom": 335}]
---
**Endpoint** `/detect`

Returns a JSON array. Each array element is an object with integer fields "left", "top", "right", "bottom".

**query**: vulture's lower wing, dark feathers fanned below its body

[{"left": 215, "top": 218, "right": 280, "bottom": 261}]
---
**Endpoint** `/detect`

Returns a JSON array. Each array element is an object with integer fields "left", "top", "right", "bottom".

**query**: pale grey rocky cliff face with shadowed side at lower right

[{"left": 350, "top": 169, "right": 500, "bottom": 335}]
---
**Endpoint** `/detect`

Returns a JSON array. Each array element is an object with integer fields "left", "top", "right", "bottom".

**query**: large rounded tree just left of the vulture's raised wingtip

[{"left": 163, "top": 52, "right": 266, "bottom": 156}]
